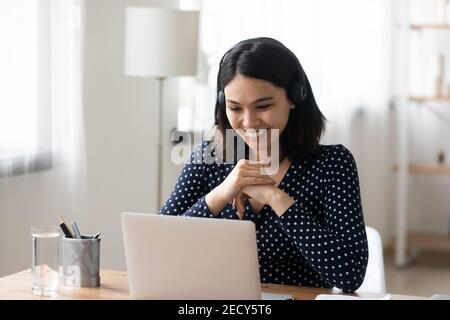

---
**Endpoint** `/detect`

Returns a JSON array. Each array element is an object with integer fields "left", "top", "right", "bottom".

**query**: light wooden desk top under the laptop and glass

[{"left": 0, "top": 269, "right": 425, "bottom": 300}]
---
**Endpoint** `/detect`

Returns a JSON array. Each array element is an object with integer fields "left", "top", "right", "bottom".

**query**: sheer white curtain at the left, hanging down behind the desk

[{"left": 0, "top": 0, "right": 87, "bottom": 275}]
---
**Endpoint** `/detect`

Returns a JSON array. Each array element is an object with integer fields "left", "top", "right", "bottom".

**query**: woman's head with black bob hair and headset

[{"left": 216, "top": 38, "right": 325, "bottom": 165}]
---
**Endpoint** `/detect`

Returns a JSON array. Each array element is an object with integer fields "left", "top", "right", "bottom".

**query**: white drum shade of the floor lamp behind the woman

[{"left": 125, "top": 7, "right": 199, "bottom": 77}]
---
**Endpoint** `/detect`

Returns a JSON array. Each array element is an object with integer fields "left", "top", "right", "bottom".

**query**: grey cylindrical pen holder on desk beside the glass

[{"left": 62, "top": 235, "right": 100, "bottom": 287}]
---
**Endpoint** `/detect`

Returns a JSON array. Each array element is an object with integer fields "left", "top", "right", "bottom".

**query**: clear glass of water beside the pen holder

[{"left": 31, "top": 226, "right": 61, "bottom": 296}]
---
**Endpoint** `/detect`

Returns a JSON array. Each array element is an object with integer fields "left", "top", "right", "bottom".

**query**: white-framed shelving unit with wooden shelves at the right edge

[{"left": 393, "top": 1, "right": 450, "bottom": 267}]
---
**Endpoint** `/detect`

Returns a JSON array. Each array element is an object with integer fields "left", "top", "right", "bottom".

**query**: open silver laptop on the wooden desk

[{"left": 122, "top": 213, "right": 261, "bottom": 300}]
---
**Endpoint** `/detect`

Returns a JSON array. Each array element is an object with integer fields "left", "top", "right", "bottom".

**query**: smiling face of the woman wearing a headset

[{"left": 224, "top": 74, "right": 293, "bottom": 151}]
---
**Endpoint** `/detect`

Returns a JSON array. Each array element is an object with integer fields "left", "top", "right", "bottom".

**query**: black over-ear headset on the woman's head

[{"left": 214, "top": 38, "right": 308, "bottom": 125}]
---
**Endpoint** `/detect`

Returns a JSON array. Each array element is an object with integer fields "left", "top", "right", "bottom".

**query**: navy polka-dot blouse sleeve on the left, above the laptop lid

[{"left": 159, "top": 145, "right": 214, "bottom": 218}]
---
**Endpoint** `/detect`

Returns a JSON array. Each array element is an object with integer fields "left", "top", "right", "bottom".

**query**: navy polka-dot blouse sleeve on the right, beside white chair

[{"left": 277, "top": 145, "right": 368, "bottom": 292}]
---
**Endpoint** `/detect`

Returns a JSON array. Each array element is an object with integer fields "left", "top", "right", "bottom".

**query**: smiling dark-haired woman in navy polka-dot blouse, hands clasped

[{"left": 160, "top": 38, "right": 368, "bottom": 292}]
